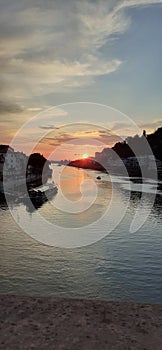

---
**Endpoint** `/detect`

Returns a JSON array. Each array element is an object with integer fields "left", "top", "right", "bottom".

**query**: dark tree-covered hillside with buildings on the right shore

[{"left": 95, "top": 128, "right": 162, "bottom": 178}]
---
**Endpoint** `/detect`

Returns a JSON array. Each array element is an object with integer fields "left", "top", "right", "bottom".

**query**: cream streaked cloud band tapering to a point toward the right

[{"left": 1, "top": 55, "right": 121, "bottom": 98}]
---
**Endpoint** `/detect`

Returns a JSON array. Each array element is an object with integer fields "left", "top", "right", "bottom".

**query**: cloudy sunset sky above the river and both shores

[{"left": 0, "top": 0, "right": 162, "bottom": 158}]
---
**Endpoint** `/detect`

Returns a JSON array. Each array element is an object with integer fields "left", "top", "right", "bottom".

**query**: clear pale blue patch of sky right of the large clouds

[{"left": 51, "top": 4, "right": 162, "bottom": 123}]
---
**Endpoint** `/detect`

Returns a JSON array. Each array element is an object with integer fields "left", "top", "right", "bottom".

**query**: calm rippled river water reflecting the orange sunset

[{"left": 0, "top": 166, "right": 162, "bottom": 303}]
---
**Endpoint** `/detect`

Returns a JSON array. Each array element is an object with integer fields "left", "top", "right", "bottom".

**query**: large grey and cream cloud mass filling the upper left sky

[{"left": 0, "top": 0, "right": 162, "bottom": 99}]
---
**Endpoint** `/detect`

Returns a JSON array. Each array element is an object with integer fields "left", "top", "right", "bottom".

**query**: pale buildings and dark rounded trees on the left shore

[{"left": 0, "top": 145, "right": 52, "bottom": 193}]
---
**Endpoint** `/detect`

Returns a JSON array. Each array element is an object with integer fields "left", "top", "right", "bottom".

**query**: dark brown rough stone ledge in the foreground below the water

[{"left": 0, "top": 296, "right": 162, "bottom": 350}]
